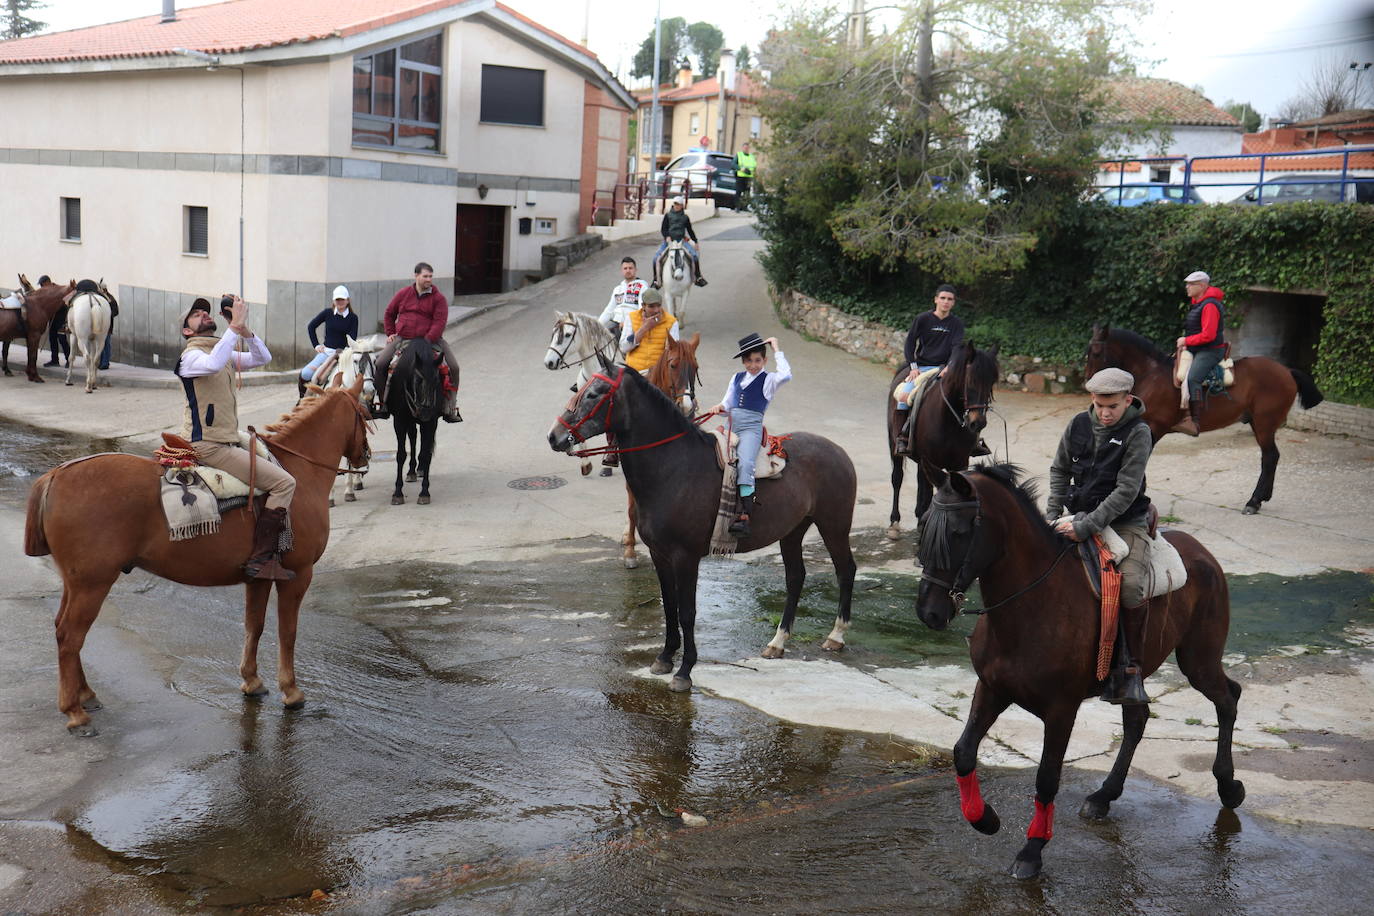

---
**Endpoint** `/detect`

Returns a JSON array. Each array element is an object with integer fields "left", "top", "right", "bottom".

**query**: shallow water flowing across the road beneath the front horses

[{"left": 8, "top": 420, "right": 1374, "bottom": 913}]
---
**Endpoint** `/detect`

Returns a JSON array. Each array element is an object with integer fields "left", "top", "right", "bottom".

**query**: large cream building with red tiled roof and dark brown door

[{"left": 0, "top": 0, "right": 635, "bottom": 368}]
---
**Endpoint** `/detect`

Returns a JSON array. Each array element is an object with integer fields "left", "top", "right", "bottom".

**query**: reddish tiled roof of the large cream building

[{"left": 0, "top": 0, "right": 595, "bottom": 67}]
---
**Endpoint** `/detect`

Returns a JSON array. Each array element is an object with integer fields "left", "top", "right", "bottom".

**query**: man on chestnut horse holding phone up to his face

[{"left": 172, "top": 295, "right": 295, "bottom": 581}]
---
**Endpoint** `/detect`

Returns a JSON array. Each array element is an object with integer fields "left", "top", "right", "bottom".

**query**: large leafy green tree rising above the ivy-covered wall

[{"left": 763, "top": 0, "right": 1148, "bottom": 282}]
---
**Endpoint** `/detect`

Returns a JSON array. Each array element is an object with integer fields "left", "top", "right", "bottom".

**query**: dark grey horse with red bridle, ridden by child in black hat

[{"left": 548, "top": 367, "right": 857, "bottom": 692}]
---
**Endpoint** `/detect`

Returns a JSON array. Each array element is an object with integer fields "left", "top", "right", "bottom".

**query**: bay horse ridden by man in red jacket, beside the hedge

[{"left": 1083, "top": 325, "right": 1325, "bottom": 515}]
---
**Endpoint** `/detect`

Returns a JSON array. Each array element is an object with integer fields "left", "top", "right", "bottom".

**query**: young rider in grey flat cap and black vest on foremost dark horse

[{"left": 1046, "top": 369, "right": 1153, "bottom": 706}]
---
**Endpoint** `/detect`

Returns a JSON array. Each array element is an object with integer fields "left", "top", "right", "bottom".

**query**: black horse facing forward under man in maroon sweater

[{"left": 386, "top": 338, "right": 444, "bottom": 505}]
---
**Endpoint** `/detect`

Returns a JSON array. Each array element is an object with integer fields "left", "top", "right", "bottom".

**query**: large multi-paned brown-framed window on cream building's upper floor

[{"left": 353, "top": 33, "right": 444, "bottom": 152}]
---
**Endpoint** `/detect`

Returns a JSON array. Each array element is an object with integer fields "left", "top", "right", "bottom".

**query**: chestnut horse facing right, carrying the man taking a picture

[{"left": 23, "top": 379, "right": 368, "bottom": 736}]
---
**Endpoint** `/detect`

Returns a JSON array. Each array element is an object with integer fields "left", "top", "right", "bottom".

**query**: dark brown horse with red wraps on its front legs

[{"left": 916, "top": 464, "right": 1245, "bottom": 878}]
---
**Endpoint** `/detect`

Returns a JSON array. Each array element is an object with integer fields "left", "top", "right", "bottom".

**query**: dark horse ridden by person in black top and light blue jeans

[{"left": 886, "top": 343, "right": 1000, "bottom": 541}]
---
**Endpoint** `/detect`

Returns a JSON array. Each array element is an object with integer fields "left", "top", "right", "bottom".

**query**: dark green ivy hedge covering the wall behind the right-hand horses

[{"left": 760, "top": 198, "right": 1374, "bottom": 405}]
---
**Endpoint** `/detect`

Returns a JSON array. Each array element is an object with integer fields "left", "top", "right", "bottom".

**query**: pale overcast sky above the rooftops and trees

[{"left": 30, "top": 0, "right": 1374, "bottom": 114}]
